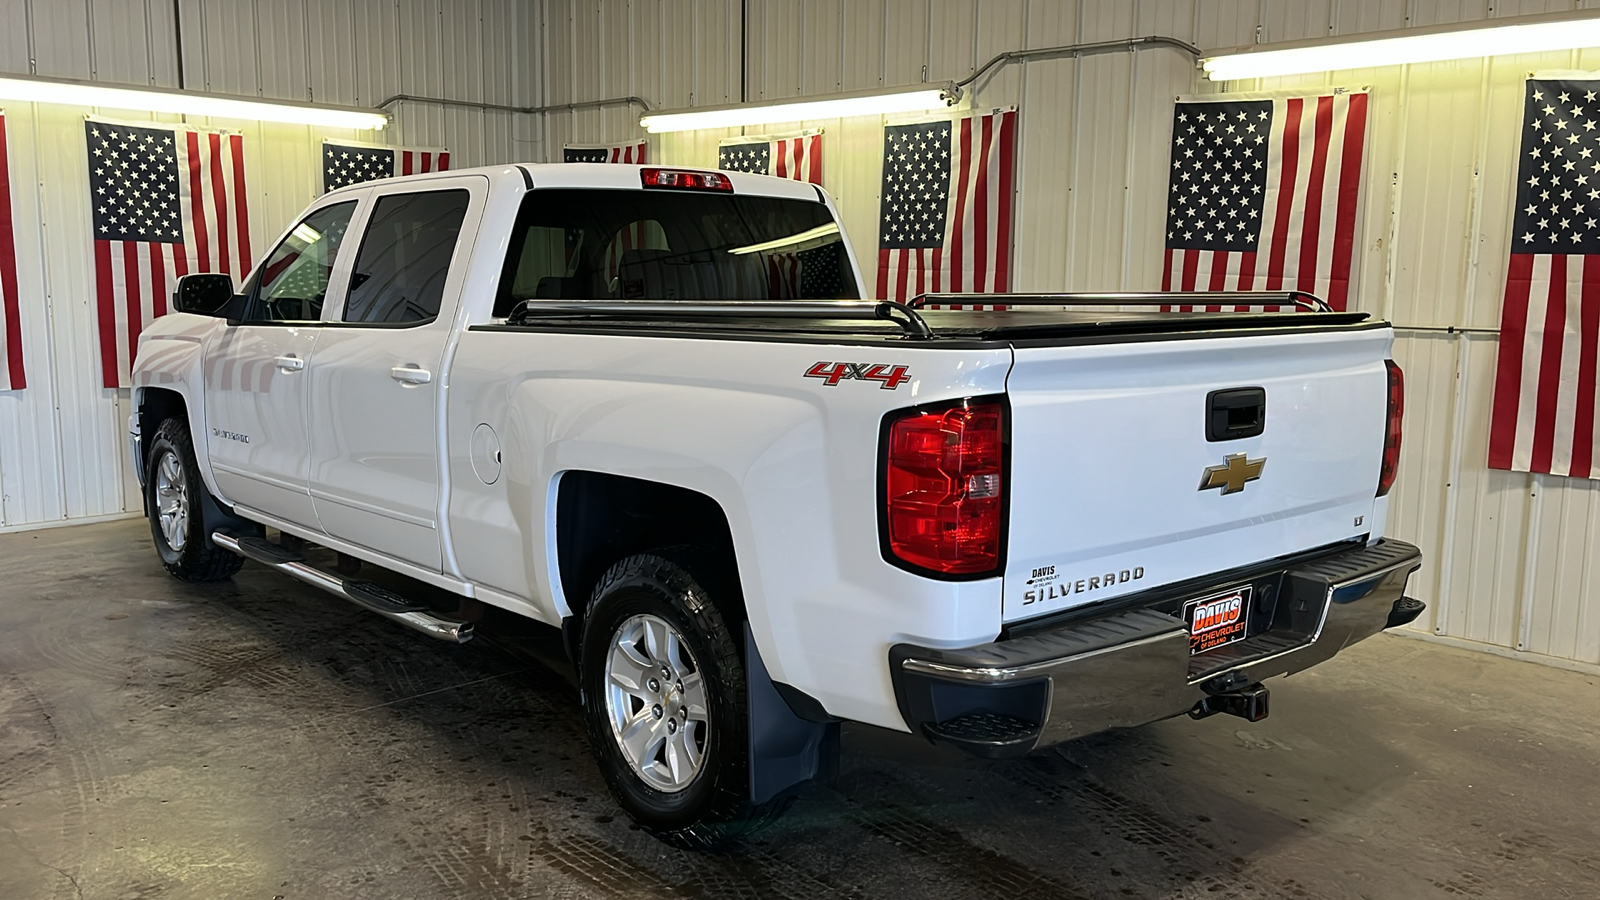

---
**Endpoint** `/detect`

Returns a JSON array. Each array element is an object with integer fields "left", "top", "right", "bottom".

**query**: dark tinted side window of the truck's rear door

[{"left": 344, "top": 191, "right": 470, "bottom": 323}]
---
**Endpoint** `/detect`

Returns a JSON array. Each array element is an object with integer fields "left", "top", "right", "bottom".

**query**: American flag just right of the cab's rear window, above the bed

[{"left": 877, "top": 109, "right": 1016, "bottom": 301}]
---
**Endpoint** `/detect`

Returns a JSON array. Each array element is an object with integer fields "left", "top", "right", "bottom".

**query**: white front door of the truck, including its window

[{"left": 195, "top": 200, "right": 357, "bottom": 528}]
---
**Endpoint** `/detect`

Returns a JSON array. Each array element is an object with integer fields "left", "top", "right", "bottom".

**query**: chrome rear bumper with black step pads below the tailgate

[{"left": 890, "top": 540, "right": 1422, "bottom": 756}]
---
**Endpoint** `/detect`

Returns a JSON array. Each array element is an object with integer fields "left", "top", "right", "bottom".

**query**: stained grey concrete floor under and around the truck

[{"left": 0, "top": 522, "right": 1600, "bottom": 900}]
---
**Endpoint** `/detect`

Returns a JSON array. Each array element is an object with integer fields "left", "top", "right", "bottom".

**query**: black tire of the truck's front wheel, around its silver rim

[{"left": 144, "top": 418, "right": 245, "bottom": 581}]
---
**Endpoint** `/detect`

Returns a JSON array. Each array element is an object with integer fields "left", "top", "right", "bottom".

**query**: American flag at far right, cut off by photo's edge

[{"left": 1490, "top": 78, "right": 1600, "bottom": 479}]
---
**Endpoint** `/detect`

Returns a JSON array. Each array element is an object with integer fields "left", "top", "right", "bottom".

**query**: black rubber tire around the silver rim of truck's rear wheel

[{"left": 579, "top": 551, "right": 789, "bottom": 849}]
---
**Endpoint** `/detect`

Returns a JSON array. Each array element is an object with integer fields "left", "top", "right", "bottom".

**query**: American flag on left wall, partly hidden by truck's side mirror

[{"left": 85, "top": 119, "right": 251, "bottom": 388}]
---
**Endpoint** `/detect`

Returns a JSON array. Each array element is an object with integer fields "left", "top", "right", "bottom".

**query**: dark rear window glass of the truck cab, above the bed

[{"left": 494, "top": 189, "right": 861, "bottom": 317}]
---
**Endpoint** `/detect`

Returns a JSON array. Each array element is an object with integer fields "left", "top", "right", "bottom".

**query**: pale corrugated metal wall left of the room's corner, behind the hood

[{"left": 0, "top": 0, "right": 538, "bottom": 530}]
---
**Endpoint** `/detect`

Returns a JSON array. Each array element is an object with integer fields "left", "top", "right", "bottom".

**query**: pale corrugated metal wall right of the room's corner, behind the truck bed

[{"left": 538, "top": 0, "right": 1600, "bottom": 665}]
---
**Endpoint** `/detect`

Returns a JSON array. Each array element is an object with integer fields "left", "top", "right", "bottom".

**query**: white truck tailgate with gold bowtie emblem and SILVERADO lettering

[{"left": 1003, "top": 328, "right": 1394, "bottom": 623}]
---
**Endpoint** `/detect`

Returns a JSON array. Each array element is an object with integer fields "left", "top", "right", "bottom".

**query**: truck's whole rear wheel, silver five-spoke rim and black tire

[{"left": 581, "top": 554, "right": 782, "bottom": 849}]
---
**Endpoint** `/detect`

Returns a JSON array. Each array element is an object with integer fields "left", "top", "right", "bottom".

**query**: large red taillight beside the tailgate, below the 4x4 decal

[{"left": 883, "top": 402, "right": 1005, "bottom": 575}]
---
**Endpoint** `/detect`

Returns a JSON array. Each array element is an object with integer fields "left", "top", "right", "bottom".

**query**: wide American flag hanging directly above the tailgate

[{"left": 1162, "top": 91, "right": 1368, "bottom": 309}]
